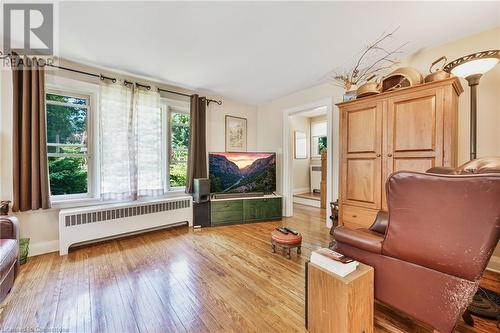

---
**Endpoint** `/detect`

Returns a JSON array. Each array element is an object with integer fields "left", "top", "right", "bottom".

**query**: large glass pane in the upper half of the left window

[{"left": 46, "top": 104, "right": 87, "bottom": 144}]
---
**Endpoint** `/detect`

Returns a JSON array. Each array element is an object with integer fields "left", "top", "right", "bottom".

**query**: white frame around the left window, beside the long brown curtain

[{"left": 45, "top": 76, "right": 100, "bottom": 202}]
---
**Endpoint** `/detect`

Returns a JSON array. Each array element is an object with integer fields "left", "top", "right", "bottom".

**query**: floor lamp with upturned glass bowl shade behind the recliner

[{"left": 444, "top": 50, "right": 500, "bottom": 160}]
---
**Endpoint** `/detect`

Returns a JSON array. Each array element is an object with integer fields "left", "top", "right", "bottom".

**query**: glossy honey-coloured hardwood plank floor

[{"left": 0, "top": 205, "right": 496, "bottom": 333}]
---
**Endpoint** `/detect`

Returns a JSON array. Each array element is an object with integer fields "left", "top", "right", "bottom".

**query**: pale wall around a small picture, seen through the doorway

[{"left": 289, "top": 115, "right": 311, "bottom": 193}]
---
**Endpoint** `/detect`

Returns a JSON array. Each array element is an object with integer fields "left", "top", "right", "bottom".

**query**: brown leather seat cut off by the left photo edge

[{"left": 0, "top": 216, "right": 19, "bottom": 303}]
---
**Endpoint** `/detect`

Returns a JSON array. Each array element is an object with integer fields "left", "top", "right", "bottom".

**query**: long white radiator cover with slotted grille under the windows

[{"left": 59, "top": 196, "right": 193, "bottom": 255}]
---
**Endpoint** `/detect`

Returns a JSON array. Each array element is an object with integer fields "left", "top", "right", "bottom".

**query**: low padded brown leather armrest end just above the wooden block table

[{"left": 333, "top": 226, "right": 384, "bottom": 254}]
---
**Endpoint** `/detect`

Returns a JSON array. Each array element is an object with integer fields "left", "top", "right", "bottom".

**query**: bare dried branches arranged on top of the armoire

[{"left": 332, "top": 28, "right": 408, "bottom": 91}]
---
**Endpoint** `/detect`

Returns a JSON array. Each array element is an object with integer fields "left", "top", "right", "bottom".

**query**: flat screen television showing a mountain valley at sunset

[{"left": 208, "top": 152, "right": 276, "bottom": 193}]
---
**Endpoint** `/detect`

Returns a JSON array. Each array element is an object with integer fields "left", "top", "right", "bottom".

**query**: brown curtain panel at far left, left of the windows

[{"left": 12, "top": 57, "right": 50, "bottom": 211}]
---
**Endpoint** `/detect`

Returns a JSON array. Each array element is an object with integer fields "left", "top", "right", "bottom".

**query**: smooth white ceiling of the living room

[{"left": 59, "top": 1, "right": 500, "bottom": 104}]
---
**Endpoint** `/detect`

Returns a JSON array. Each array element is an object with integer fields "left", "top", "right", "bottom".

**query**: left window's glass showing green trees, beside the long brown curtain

[{"left": 46, "top": 92, "right": 90, "bottom": 197}]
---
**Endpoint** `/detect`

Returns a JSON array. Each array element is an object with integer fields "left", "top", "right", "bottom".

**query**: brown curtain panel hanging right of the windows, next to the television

[{"left": 186, "top": 95, "right": 207, "bottom": 193}]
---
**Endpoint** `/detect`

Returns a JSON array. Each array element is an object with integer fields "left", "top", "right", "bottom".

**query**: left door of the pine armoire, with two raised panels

[{"left": 341, "top": 101, "right": 382, "bottom": 209}]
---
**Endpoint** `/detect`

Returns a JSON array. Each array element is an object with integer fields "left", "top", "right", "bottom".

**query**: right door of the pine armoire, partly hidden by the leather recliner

[{"left": 382, "top": 88, "right": 444, "bottom": 210}]
